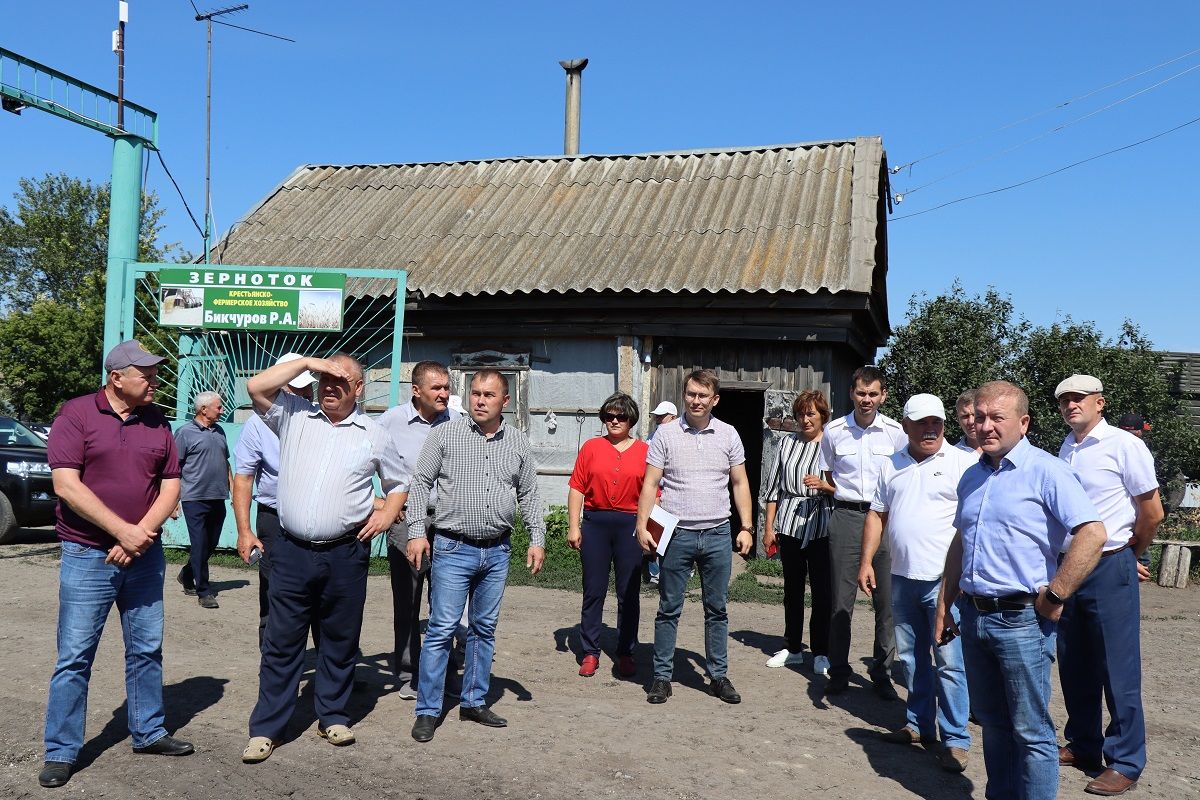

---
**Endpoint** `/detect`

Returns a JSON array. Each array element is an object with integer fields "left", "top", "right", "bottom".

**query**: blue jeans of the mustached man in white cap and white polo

[{"left": 892, "top": 575, "right": 971, "bottom": 750}]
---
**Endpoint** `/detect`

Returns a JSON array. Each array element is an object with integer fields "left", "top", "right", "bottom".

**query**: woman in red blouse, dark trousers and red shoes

[{"left": 566, "top": 392, "right": 648, "bottom": 678}]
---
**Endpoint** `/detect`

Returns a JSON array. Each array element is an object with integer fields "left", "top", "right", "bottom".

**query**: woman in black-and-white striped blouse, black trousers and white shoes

[{"left": 762, "top": 391, "right": 834, "bottom": 675}]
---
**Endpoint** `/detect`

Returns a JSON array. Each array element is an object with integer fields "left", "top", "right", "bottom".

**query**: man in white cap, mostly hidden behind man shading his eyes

[{"left": 233, "top": 353, "right": 318, "bottom": 644}]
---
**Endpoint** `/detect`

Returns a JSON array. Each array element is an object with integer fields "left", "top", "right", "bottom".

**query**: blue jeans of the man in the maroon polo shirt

[{"left": 46, "top": 541, "right": 167, "bottom": 764}]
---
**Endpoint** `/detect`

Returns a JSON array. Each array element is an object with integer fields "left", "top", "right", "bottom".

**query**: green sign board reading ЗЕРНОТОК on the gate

[{"left": 158, "top": 264, "right": 346, "bottom": 331}]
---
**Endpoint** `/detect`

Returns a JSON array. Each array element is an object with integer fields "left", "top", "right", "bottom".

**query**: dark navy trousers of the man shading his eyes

[{"left": 250, "top": 531, "right": 370, "bottom": 740}]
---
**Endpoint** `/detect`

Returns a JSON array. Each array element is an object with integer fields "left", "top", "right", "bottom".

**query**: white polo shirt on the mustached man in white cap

[{"left": 871, "top": 440, "right": 979, "bottom": 581}]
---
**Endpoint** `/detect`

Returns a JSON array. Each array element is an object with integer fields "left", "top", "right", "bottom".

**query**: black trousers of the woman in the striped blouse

[{"left": 775, "top": 536, "right": 833, "bottom": 656}]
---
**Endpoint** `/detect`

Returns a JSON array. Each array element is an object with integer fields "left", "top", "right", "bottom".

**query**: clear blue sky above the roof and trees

[{"left": 0, "top": 0, "right": 1200, "bottom": 350}]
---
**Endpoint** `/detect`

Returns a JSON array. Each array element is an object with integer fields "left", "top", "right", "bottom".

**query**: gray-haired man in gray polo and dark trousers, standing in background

[{"left": 175, "top": 392, "right": 233, "bottom": 608}]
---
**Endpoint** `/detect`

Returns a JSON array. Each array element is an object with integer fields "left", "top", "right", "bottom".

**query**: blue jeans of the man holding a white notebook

[{"left": 654, "top": 522, "right": 733, "bottom": 680}]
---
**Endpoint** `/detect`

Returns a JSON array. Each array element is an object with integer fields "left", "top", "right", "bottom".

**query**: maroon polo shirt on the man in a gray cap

[{"left": 47, "top": 389, "right": 179, "bottom": 551}]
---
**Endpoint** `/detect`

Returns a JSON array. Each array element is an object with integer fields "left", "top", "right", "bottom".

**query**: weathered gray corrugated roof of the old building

[{"left": 215, "top": 137, "right": 883, "bottom": 296}]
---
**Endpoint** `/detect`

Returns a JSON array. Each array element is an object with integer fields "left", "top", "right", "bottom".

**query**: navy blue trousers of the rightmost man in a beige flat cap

[{"left": 1058, "top": 549, "right": 1146, "bottom": 781}]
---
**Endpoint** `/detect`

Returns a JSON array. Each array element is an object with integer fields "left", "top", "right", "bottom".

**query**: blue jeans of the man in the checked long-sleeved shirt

[{"left": 415, "top": 534, "right": 512, "bottom": 716}]
